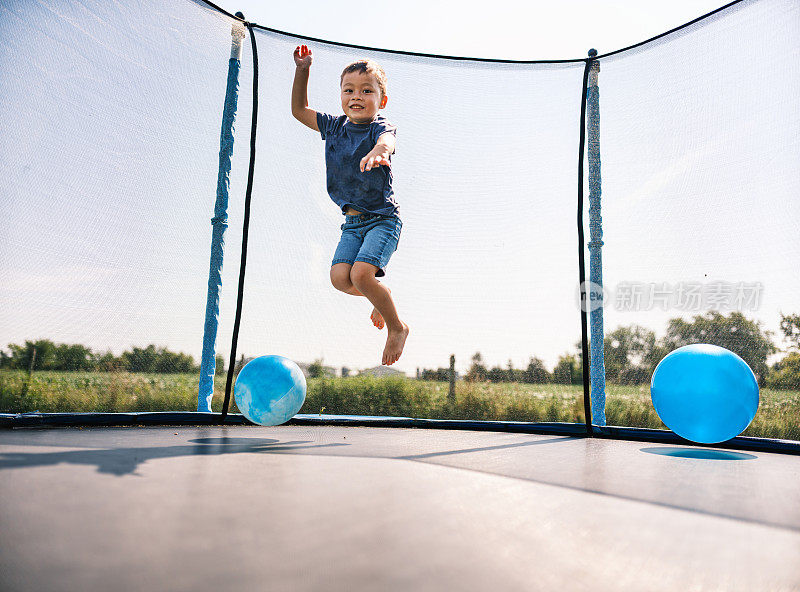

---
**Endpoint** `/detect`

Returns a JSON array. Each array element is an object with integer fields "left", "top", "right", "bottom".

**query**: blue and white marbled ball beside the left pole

[{"left": 233, "top": 356, "right": 306, "bottom": 425}]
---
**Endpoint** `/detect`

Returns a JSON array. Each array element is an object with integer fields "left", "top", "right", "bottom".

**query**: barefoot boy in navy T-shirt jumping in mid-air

[{"left": 292, "top": 45, "right": 409, "bottom": 365}]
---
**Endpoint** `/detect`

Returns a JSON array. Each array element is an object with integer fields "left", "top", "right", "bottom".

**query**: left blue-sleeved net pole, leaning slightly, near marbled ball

[{"left": 197, "top": 20, "right": 244, "bottom": 413}]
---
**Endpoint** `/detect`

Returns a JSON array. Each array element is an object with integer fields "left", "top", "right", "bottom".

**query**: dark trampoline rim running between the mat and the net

[{"left": 0, "top": 411, "right": 800, "bottom": 455}]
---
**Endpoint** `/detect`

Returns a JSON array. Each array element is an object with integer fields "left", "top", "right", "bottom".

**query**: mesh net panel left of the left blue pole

[{"left": 0, "top": 2, "right": 252, "bottom": 411}]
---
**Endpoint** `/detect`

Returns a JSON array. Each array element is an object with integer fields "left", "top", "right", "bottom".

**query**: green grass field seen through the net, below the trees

[{"left": 0, "top": 370, "right": 800, "bottom": 440}]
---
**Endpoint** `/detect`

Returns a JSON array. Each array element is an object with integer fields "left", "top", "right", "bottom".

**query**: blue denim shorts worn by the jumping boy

[{"left": 331, "top": 213, "right": 403, "bottom": 277}]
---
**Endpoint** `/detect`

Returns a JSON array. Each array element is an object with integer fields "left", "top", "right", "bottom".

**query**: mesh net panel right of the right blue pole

[{"left": 600, "top": 2, "right": 800, "bottom": 438}]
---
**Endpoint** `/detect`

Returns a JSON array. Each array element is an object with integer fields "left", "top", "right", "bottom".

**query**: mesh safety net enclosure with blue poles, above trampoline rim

[{"left": 0, "top": 0, "right": 800, "bottom": 448}]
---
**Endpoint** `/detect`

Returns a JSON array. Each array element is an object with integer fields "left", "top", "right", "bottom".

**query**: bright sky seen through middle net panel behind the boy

[{"left": 240, "top": 31, "right": 583, "bottom": 375}]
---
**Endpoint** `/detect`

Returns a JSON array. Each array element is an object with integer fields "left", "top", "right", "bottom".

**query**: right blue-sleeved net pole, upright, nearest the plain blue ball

[{"left": 586, "top": 49, "right": 606, "bottom": 426}]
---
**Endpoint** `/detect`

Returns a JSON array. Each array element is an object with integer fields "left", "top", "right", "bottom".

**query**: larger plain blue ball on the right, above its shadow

[{"left": 650, "top": 343, "right": 758, "bottom": 444}]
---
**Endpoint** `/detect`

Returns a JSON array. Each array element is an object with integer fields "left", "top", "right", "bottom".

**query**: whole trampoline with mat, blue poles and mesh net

[{"left": 0, "top": 0, "right": 800, "bottom": 592}]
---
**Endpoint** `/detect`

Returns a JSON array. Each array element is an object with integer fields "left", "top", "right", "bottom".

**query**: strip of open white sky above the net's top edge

[{"left": 218, "top": 0, "right": 726, "bottom": 60}]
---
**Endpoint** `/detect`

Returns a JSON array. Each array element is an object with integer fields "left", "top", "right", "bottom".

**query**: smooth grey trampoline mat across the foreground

[{"left": 0, "top": 426, "right": 800, "bottom": 591}]
